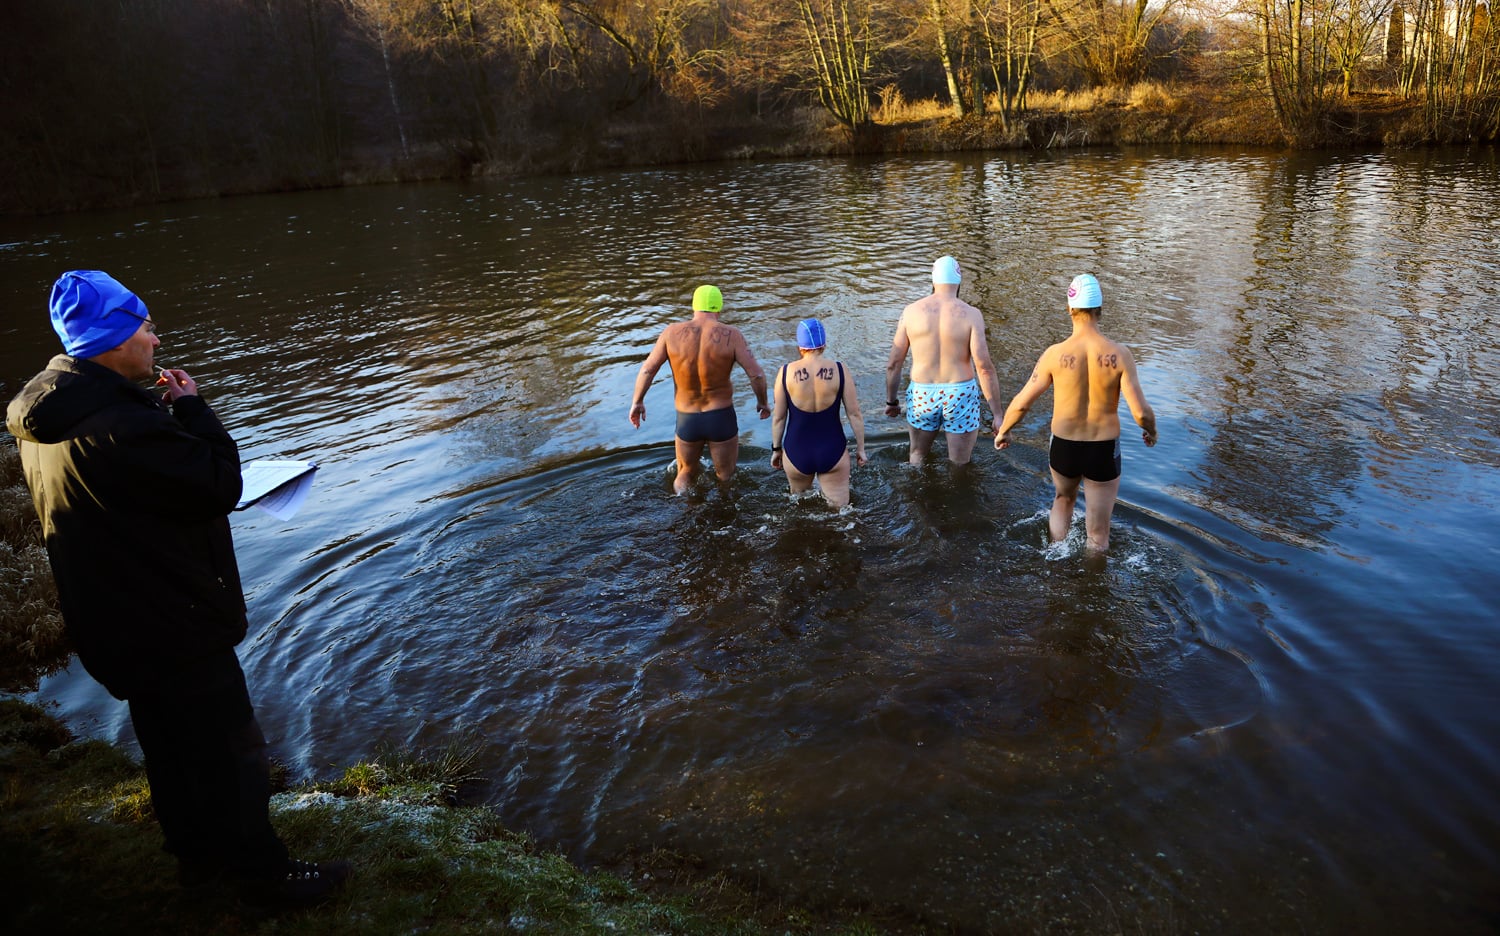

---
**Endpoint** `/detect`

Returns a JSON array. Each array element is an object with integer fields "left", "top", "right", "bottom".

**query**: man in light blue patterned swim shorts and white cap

[{"left": 885, "top": 257, "right": 1001, "bottom": 465}]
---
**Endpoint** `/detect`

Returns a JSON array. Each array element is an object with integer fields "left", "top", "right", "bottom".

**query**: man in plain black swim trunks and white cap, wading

[{"left": 995, "top": 273, "right": 1157, "bottom": 552}]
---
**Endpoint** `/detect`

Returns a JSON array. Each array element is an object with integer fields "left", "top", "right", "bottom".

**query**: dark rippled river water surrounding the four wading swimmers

[{"left": 0, "top": 149, "right": 1500, "bottom": 933}]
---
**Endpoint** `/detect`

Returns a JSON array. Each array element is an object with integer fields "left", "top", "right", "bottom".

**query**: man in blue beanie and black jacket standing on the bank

[{"left": 6, "top": 270, "right": 350, "bottom": 906}]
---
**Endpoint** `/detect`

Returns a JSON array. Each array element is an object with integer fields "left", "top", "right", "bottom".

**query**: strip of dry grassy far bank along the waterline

[{"left": 301, "top": 81, "right": 1430, "bottom": 191}]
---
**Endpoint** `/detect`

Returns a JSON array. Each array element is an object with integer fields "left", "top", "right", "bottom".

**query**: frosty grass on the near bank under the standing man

[{"left": 0, "top": 699, "right": 882, "bottom": 936}]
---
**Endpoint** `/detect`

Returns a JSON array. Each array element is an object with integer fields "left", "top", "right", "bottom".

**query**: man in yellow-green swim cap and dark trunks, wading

[{"left": 630, "top": 285, "right": 771, "bottom": 494}]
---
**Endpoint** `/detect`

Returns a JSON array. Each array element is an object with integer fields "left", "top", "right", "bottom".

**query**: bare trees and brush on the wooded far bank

[{"left": 0, "top": 0, "right": 1500, "bottom": 215}]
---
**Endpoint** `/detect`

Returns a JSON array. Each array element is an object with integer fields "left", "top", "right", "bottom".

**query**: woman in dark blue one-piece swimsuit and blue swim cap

[{"left": 771, "top": 318, "right": 869, "bottom": 507}]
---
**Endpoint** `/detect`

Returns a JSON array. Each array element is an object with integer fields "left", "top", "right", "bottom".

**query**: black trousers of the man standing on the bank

[{"left": 129, "top": 651, "right": 287, "bottom": 879}]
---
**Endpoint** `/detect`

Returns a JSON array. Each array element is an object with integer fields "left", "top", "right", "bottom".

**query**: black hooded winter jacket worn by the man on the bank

[{"left": 6, "top": 354, "right": 248, "bottom": 699}]
